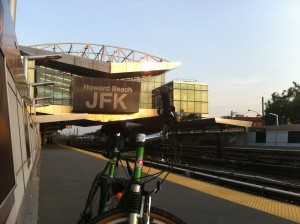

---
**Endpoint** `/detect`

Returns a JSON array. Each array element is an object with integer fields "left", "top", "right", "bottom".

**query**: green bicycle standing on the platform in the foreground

[{"left": 78, "top": 88, "right": 185, "bottom": 224}]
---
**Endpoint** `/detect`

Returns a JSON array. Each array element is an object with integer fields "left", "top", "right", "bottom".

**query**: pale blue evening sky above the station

[{"left": 16, "top": 0, "right": 300, "bottom": 121}]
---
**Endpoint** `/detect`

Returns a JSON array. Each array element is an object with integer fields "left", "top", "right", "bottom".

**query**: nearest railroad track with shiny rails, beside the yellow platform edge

[{"left": 143, "top": 159, "right": 300, "bottom": 205}]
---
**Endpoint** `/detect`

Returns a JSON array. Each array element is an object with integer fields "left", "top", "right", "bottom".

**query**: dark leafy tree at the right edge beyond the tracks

[{"left": 264, "top": 82, "right": 300, "bottom": 125}]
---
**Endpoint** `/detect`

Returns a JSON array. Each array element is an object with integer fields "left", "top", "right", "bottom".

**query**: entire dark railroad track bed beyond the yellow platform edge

[{"left": 61, "top": 143, "right": 300, "bottom": 205}]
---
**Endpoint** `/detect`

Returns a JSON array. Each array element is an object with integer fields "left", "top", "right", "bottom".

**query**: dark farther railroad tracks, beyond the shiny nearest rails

[{"left": 147, "top": 145, "right": 300, "bottom": 178}]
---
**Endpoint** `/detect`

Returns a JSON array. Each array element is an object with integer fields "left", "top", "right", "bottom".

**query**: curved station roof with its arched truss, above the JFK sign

[{"left": 19, "top": 43, "right": 181, "bottom": 79}]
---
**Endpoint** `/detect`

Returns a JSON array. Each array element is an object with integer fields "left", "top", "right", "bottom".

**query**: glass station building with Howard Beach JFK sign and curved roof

[{"left": 19, "top": 43, "right": 208, "bottom": 136}]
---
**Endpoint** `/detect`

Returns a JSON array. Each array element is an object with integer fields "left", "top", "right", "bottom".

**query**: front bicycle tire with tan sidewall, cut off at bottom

[{"left": 89, "top": 207, "right": 186, "bottom": 224}]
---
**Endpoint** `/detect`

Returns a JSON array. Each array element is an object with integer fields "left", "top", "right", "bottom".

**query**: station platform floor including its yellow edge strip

[{"left": 24, "top": 144, "right": 300, "bottom": 224}]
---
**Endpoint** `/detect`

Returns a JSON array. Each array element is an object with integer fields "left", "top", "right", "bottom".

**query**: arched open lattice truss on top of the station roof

[{"left": 29, "top": 43, "right": 169, "bottom": 63}]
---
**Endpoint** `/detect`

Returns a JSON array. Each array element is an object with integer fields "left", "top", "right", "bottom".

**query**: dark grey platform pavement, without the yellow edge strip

[{"left": 26, "top": 144, "right": 300, "bottom": 224}]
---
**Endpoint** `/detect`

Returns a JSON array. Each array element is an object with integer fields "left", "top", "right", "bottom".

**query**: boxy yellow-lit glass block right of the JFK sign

[{"left": 152, "top": 80, "right": 208, "bottom": 117}]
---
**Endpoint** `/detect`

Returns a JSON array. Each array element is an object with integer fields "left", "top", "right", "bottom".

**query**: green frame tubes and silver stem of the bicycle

[{"left": 82, "top": 133, "right": 164, "bottom": 223}]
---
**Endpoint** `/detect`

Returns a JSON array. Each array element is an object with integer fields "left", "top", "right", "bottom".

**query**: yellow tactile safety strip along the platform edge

[{"left": 63, "top": 147, "right": 300, "bottom": 223}]
